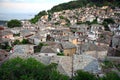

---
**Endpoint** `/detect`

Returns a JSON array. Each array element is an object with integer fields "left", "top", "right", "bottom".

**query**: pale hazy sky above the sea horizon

[{"left": 0, "top": 0, "right": 71, "bottom": 13}]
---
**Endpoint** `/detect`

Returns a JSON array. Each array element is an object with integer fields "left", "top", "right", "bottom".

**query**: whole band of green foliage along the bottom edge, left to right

[{"left": 0, "top": 57, "right": 120, "bottom": 80}]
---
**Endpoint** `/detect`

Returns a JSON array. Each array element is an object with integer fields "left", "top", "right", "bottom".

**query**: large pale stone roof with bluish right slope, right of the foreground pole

[{"left": 74, "top": 55, "right": 100, "bottom": 73}]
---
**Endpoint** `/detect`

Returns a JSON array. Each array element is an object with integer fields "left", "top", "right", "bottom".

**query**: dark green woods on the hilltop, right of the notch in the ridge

[{"left": 50, "top": 0, "right": 120, "bottom": 12}]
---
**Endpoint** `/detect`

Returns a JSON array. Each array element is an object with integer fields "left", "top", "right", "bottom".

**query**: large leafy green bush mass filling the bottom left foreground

[{"left": 0, "top": 58, "right": 68, "bottom": 80}]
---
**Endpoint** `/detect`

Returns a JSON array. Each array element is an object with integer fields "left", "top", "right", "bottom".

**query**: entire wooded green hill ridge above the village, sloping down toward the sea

[{"left": 30, "top": 0, "right": 120, "bottom": 23}]
